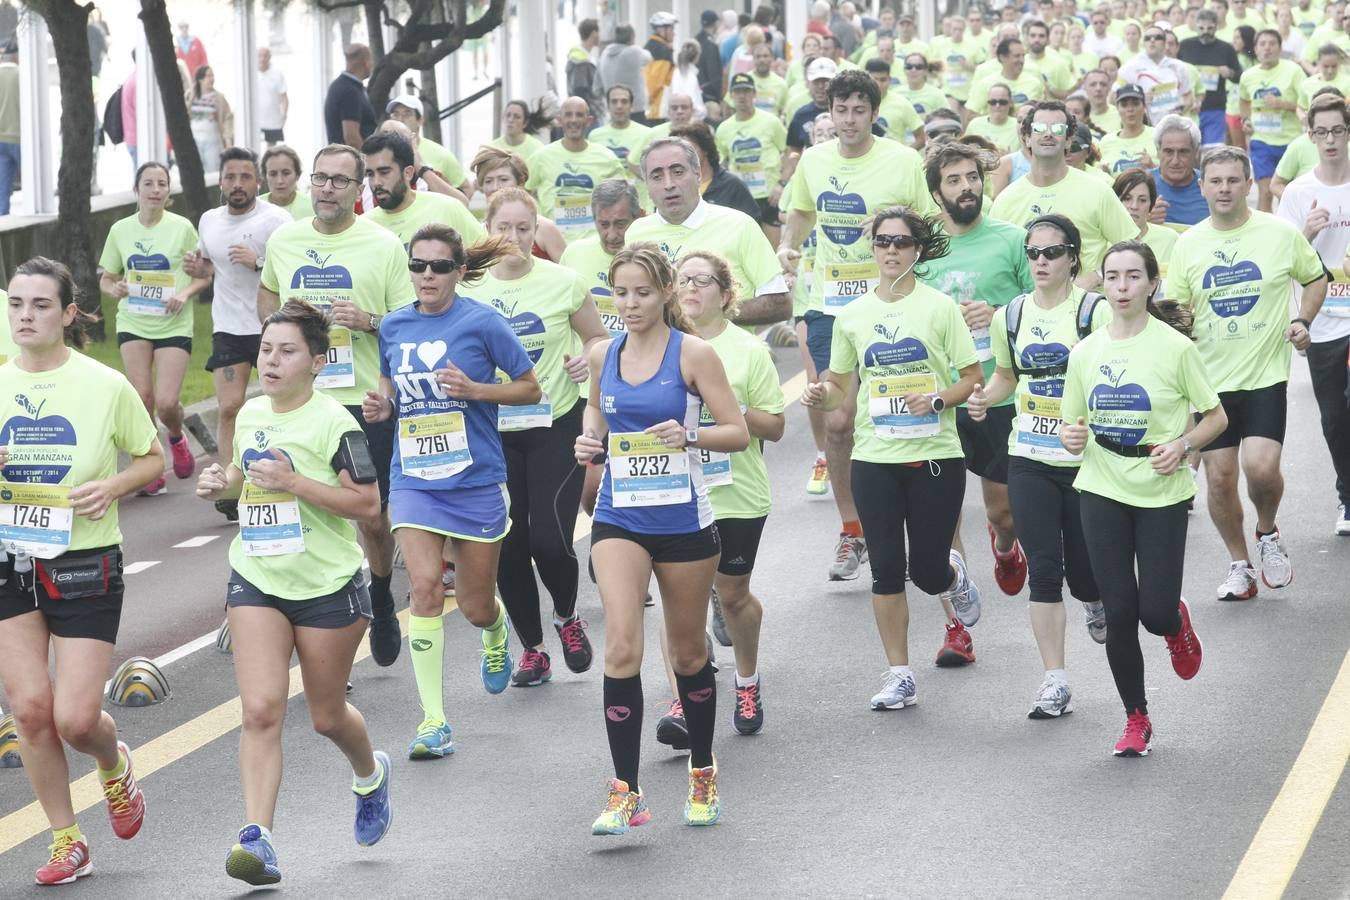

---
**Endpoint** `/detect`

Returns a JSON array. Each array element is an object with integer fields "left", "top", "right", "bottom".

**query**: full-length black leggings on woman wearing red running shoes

[{"left": 1080, "top": 491, "right": 1187, "bottom": 714}]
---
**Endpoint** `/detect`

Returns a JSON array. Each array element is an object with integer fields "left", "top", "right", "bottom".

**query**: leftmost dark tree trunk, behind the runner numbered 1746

[{"left": 28, "top": 0, "right": 104, "bottom": 334}]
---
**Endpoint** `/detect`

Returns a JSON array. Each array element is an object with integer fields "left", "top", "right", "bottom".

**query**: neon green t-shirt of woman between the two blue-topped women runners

[{"left": 459, "top": 259, "right": 586, "bottom": 421}]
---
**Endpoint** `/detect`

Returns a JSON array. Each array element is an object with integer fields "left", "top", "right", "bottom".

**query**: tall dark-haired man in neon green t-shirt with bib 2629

[{"left": 778, "top": 72, "right": 936, "bottom": 582}]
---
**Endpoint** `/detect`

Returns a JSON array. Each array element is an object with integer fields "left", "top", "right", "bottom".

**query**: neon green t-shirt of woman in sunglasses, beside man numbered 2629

[{"left": 830, "top": 283, "right": 977, "bottom": 463}]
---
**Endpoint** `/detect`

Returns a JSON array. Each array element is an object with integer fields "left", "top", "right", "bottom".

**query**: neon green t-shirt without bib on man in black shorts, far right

[{"left": 1166, "top": 209, "right": 1324, "bottom": 391}]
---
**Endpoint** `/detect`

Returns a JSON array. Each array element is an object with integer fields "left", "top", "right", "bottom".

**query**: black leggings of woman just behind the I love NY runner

[{"left": 497, "top": 399, "right": 586, "bottom": 648}]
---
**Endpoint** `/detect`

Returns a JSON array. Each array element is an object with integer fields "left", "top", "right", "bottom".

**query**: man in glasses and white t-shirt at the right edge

[{"left": 1276, "top": 94, "right": 1350, "bottom": 534}]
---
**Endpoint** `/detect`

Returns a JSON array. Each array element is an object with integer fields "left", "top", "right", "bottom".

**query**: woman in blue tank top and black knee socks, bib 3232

[{"left": 575, "top": 243, "right": 749, "bottom": 834}]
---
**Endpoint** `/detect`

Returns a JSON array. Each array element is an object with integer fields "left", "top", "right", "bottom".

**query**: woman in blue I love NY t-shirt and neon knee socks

[{"left": 362, "top": 224, "right": 541, "bottom": 760}]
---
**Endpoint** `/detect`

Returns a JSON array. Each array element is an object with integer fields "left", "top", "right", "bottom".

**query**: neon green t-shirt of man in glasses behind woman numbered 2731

[{"left": 262, "top": 216, "right": 413, "bottom": 406}]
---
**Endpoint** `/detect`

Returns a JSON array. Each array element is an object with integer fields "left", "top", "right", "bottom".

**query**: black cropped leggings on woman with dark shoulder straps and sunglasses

[{"left": 1008, "top": 456, "right": 1099, "bottom": 603}]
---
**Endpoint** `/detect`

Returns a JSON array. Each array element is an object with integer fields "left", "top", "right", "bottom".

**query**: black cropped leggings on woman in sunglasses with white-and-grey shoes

[{"left": 851, "top": 459, "right": 965, "bottom": 595}]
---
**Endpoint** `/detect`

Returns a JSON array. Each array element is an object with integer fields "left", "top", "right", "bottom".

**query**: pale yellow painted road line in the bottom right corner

[{"left": 1223, "top": 653, "right": 1350, "bottom": 900}]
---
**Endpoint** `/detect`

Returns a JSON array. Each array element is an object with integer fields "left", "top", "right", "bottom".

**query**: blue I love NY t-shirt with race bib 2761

[{"left": 379, "top": 297, "right": 533, "bottom": 491}]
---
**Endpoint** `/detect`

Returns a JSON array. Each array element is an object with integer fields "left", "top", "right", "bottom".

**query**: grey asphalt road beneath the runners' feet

[{"left": 0, "top": 349, "right": 1350, "bottom": 900}]
